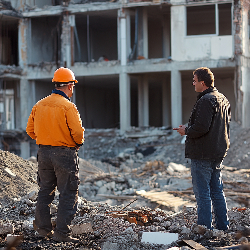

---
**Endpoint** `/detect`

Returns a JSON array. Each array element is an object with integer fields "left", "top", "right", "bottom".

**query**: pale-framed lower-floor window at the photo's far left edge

[{"left": 0, "top": 89, "right": 15, "bottom": 130}]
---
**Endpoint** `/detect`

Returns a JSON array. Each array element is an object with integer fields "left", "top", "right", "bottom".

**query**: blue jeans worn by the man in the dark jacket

[{"left": 191, "top": 159, "right": 229, "bottom": 230}]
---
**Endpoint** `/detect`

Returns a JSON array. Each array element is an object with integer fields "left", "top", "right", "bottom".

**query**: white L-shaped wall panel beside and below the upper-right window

[{"left": 171, "top": 6, "right": 233, "bottom": 61}]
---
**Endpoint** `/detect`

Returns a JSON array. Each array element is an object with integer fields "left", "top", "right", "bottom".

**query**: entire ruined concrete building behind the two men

[{"left": 0, "top": 0, "right": 250, "bottom": 159}]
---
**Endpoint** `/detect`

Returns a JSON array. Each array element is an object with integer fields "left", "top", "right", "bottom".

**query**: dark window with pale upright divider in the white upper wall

[{"left": 187, "top": 3, "right": 232, "bottom": 36}]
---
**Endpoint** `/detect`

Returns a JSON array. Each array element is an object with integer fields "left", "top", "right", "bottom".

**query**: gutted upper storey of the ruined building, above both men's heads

[{"left": 0, "top": 0, "right": 250, "bottom": 78}]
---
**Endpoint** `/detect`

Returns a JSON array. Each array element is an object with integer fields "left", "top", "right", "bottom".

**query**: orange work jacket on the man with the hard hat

[{"left": 26, "top": 93, "right": 84, "bottom": 147}]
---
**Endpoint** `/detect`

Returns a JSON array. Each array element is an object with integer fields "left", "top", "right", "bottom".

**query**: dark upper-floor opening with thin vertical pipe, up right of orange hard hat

[{"left": 74, "top": 10, "right": 118, "bottom": 62}]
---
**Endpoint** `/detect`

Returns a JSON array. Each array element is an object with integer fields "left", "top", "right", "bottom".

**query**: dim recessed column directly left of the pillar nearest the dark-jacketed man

[{"left": 162, "top": 79, "right": 171, "bottom": 127}]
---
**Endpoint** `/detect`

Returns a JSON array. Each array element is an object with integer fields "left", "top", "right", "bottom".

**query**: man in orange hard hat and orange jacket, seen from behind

[{"left": 26, "top": 67, "right": 84, "bottom": 242}]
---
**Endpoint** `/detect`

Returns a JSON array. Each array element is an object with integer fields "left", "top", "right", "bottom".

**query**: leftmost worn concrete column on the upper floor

[{"left": 18, "top": 19, "right": 29, "bottom": 69}]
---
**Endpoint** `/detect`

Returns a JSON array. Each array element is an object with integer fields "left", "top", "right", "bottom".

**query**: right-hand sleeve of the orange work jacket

[{"left": 66, "top": 104, "right": 85, "bottom": 147}]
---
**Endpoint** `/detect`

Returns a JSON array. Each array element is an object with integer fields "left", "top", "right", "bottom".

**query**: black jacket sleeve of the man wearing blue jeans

[{"left": 185, "top": 98, "right": 214, "bottom": 138}]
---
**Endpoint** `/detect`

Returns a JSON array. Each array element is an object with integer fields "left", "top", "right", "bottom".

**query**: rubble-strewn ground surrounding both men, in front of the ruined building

[{"left": 0, "top": 122, "right": 250, "bottom": 250}]
